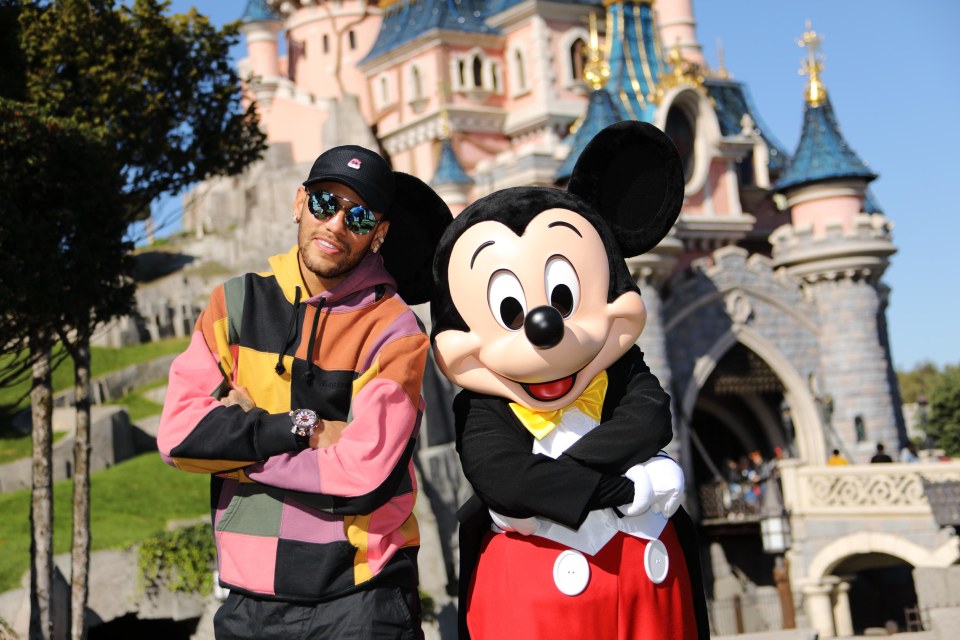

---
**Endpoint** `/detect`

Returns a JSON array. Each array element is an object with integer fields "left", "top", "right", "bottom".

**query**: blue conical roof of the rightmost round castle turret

[{"left": 775, "top": 96, "right": 877, "bottom": 191}]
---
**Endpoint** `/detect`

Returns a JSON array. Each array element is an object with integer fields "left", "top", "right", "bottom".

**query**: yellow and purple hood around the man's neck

[{"left": 269, "top": 246, "right": 397, "bottom": 306}]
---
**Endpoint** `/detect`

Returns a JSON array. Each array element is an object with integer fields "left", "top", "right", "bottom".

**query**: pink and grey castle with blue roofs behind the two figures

[{"left": 120, "top": 0, "right": 960, "bottom": 637}]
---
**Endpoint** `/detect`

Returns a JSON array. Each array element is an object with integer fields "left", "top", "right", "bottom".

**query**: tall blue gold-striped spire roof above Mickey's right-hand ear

[{"left": 604, "top": 2, "right": 663, "bottom": 122}]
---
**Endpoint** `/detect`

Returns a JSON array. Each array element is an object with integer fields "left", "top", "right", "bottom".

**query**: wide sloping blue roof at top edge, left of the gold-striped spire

[{"left": 363, "top": 0, "right": 501, "bottom": 62}]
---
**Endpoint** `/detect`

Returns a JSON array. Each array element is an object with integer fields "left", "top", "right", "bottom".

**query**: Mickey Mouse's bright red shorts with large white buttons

[{"left": 467, "top": 523, "right": 697, "bottom": 640}]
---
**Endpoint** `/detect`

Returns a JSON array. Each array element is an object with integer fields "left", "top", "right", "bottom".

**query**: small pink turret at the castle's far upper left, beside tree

[{"left": 240, "top": 0, "right": 283, "bottom": 109}]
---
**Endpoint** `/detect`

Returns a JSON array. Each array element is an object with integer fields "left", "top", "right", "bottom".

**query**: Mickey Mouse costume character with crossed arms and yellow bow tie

[{"left": 431, "top": 121, "right": 709, "bottom": 640}]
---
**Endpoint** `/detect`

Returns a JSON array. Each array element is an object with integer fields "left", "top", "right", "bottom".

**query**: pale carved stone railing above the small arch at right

[{"left": 780, "top": 461, "right": 960, "bottom": 517}]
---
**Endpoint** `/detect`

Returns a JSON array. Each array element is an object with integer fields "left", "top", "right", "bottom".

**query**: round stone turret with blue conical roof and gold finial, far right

[{"left": 770, "top": 24, "right": 904, "bottom": 461}]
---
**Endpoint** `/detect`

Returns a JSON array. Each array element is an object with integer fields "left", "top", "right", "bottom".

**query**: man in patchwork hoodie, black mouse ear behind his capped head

[{"left": 157, "top": 145, "right": 451, "bottom": 640}]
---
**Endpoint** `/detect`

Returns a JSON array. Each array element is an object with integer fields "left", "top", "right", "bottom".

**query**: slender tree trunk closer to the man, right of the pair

[{"left": 70, "top": 337, "right": 90, "bottom": 640}]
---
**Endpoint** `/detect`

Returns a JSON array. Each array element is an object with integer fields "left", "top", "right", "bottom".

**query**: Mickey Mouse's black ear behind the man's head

[{"left": 380, "top": 171, "right": 453, "bottom": 304}]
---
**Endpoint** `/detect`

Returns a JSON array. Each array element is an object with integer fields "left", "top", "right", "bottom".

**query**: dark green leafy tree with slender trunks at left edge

[{"left": 0, "top": 0, "right": 265, "bottom": 638}]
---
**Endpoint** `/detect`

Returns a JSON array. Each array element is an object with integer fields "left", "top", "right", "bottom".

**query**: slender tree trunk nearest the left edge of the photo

[{"left": 30, "top": 334, "right": 53, "bottom": 640}]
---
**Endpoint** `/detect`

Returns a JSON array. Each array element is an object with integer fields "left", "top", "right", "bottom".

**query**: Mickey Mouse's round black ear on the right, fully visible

[{"left": 567, "top": 120, "right": 684, "bottom": 258}]
